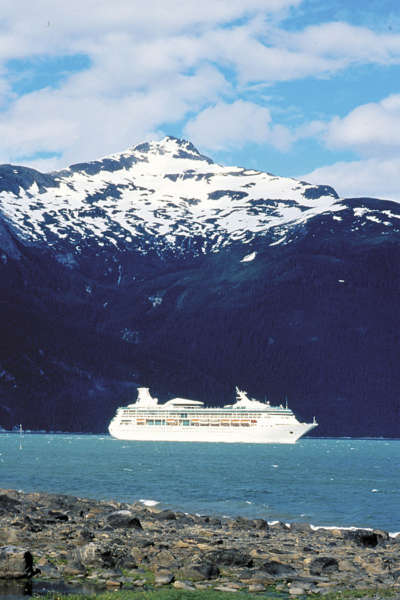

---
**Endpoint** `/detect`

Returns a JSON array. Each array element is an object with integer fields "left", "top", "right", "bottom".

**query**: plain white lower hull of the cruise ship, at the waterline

[{"left": 109, "top": 422, "right": 315, "bottom": 444}]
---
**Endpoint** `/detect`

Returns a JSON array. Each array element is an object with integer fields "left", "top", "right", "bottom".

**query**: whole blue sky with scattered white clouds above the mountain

[{"left": 0, "top": 0, "right": 400, "bottom": 201}]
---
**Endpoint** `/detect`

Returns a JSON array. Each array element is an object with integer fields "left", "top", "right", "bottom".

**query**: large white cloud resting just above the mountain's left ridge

[{"left": 0, "top": 66, "right": 227, "bottom": 166}]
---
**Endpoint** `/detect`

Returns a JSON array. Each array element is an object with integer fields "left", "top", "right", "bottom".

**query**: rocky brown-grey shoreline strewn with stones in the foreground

[{"left": 0, "top": 489, "right": 400, "bottom": 596}]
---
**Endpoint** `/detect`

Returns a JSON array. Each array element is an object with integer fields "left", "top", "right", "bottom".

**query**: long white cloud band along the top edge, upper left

[{"left": 0, "top": 0, "right": 302, "bottom": 59}]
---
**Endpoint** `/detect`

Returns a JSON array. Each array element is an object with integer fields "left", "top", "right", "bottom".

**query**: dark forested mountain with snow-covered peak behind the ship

[{"left": 0, "top": 137, "right": 400, "bottom": 436}]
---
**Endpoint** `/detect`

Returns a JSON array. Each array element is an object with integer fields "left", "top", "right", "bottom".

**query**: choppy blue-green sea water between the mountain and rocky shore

[{"left": 0, "top": 433, "right": 400, "bottom": 533}]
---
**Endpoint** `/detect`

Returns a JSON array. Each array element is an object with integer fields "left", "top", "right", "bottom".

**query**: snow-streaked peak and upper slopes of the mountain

[{"left": 0, "top": 137, "right": 344, "bottom": 252}]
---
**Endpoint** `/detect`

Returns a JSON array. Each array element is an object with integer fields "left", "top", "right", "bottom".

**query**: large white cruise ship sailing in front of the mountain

[{"left": 108, "top": 387, "right": 318, "bottom": 444}]
